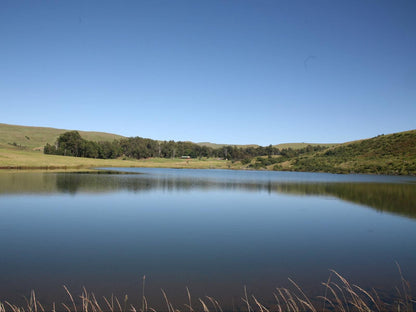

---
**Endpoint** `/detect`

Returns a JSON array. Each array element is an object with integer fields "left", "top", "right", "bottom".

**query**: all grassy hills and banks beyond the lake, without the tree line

[{"left": 0, "top": 123, "right": 416, "bottom": 175}]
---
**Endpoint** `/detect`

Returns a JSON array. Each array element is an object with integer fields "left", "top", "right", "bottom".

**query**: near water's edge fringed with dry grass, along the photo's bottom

[{"left": 0, "top": 265, "right": 416, "bottom": 312}]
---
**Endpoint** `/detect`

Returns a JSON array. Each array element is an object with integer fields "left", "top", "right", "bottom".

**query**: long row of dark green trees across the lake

[{"left": 44, "top": 131, "right": 325, "bottom": 161}]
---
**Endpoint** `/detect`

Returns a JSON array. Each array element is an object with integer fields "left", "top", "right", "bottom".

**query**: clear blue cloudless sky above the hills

[{"left": 0, "top": 0, "right": 416, "bottom": 145}]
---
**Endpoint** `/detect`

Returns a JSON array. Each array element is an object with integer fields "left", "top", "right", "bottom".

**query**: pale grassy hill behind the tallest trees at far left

[{"left": 0, "top": 123, "right": 122, "bottom": 150}]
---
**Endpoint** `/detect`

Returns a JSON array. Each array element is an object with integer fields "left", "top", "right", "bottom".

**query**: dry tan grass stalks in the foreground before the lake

[{"left": 0, "top": 266, "right": 416, "bottom": 312}]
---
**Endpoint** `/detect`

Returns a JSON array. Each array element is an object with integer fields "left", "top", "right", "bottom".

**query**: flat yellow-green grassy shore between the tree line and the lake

[{"left": 0, "top": 145, "right": 416, "bottom": 176}]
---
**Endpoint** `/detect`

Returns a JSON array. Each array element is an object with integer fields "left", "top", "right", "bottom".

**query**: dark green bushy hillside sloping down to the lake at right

[{"left": 285, "top": 130, "right": 416, "bottom": 175}]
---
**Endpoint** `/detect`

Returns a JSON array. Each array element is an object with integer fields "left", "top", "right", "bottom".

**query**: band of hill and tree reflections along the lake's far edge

[{"left": 0, "top": 170, "right": 416, "bottom": 218}]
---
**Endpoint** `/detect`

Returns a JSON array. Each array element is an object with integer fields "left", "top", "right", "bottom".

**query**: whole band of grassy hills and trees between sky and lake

[{"left": 0, "top": 124, "right": 416, "bottom": 175}]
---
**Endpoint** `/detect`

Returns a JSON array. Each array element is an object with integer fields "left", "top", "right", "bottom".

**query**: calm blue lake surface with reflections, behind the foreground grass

[{"left": 0, "top": 168, "right": 416, "bottom": 307}]
